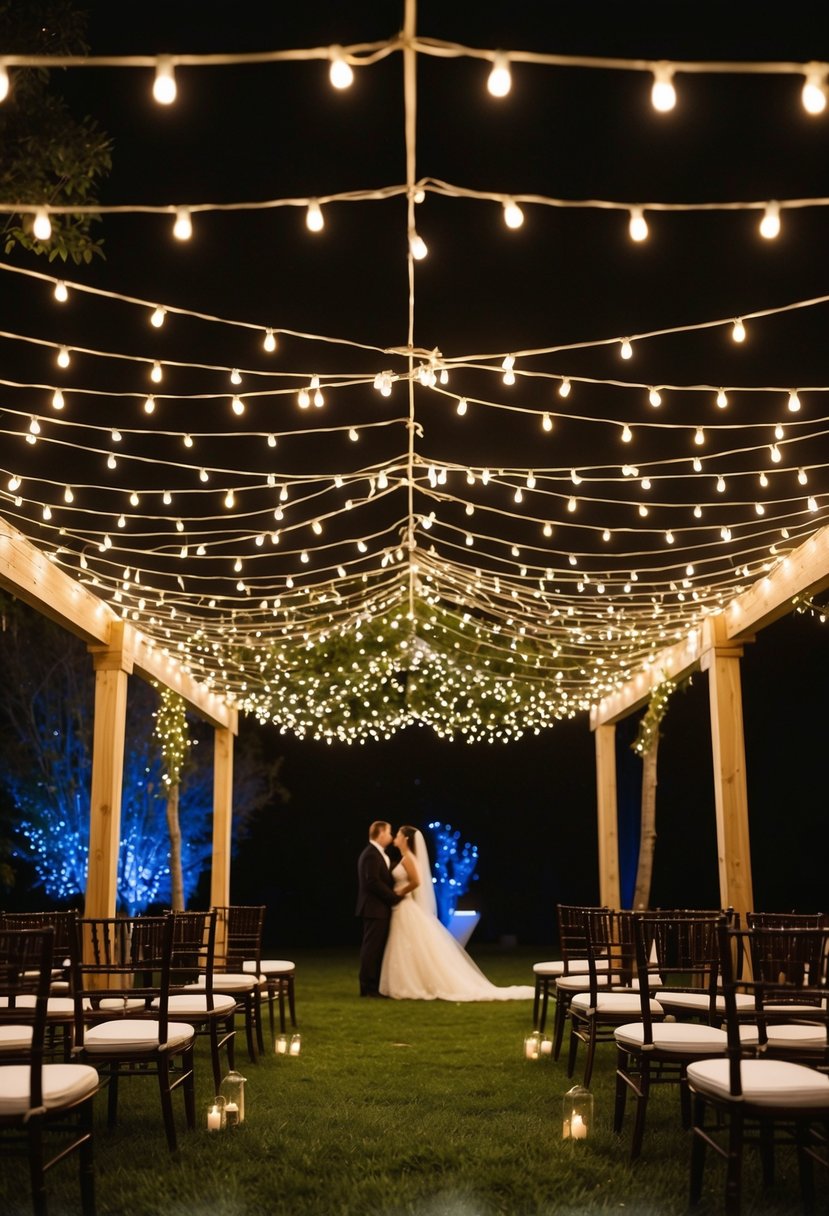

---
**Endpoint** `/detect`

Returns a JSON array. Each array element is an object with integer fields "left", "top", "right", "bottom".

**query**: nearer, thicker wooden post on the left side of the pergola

[{"left": 84, "top": 621, "right": 132, "bottom": 917}]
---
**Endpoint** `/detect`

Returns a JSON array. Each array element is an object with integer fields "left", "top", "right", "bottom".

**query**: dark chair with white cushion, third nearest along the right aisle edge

[{"left": 568, "top": 910, "right": 662, "bottom": 1087}]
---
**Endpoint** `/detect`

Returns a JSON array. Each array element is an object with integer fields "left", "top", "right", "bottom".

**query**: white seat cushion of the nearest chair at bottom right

[{"left": 688, "top": 1059, "right": 829, "bottom": 1113}]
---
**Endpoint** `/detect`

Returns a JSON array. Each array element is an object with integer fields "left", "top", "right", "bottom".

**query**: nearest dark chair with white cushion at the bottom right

[{"left": 687, "top": 921, "right": 829, "bottom": 1216}]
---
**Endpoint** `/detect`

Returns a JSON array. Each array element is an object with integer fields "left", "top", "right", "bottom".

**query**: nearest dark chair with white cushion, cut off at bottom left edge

[{"left": 0, "top": 928, "right": 100, "bottom": 1216}]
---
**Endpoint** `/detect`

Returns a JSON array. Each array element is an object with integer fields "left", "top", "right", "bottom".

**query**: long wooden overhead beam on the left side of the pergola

[{"left": 0, "top": 510, "right": 238, "bottom": 719}]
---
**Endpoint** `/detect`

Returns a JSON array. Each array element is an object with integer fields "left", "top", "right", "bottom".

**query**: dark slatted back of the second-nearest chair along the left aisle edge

[{"left": 72, "top": 916, "right": 174, "bottom": 1047}]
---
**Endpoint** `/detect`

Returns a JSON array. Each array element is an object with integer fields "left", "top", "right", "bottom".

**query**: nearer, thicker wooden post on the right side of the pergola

[{"left": 701, "top": 617, "right": 754, "bottom": 918}]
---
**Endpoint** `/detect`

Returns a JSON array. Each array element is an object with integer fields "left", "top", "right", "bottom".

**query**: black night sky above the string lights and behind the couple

[{"left": 2, "top": 0, "right": 829, "bottom": 947}]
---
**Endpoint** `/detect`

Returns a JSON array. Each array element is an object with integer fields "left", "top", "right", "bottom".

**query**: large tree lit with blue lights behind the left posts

[{"left": 0, "top": 598, "right": 288, "bottom": 913}]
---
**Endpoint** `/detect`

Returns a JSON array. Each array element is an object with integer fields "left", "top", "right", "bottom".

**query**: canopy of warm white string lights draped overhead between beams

[{"left": 0, "top": 0, "right": 829, "bottom": 742}]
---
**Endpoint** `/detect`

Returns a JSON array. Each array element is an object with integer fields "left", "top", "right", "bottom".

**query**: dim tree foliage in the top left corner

[{"left": 0, "top": 0, "right": 112, "bottom": 263}]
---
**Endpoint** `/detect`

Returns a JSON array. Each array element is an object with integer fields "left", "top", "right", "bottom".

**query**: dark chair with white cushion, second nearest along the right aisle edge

[{"left": 614, "top": 911, "right": 727, "bottom": 1160}]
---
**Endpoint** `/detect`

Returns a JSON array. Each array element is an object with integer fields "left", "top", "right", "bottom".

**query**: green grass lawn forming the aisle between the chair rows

[{"left": 0, "top": 947, "right": 811, "bottom": 1216}]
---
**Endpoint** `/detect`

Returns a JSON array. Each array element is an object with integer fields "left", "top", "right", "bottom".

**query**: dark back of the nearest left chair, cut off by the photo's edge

[{"left": 0, "top": 927, "right": 55, "bottom": 1111}]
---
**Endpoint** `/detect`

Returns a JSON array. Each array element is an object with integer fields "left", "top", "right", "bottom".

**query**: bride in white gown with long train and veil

[{"left": 380, "top": 824, "right": 534, "bottom": 1001}]
